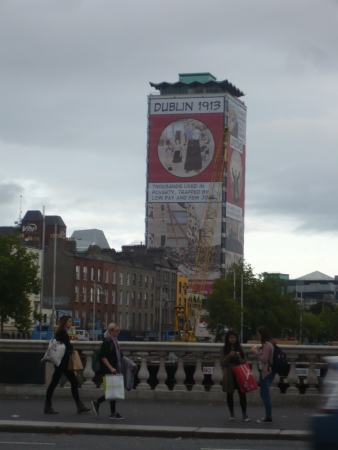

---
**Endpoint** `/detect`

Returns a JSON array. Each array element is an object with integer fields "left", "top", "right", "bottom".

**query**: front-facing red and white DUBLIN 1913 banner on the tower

[{"left": 146, "top": 97, "right": 225, "bottom": 291}]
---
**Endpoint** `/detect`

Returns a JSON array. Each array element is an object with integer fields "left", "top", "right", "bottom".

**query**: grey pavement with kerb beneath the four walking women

[{"left": 0, "top": 395, "right": 315, "bottom": 440}]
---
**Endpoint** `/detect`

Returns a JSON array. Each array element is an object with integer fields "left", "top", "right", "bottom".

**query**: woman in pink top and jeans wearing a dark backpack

[{"left": 251, "top": 326, "right": 275, "bottom": 424}]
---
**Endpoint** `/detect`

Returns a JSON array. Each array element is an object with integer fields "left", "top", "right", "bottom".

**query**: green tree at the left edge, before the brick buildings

[{"left": 0, "top": 234, "right": 40, "bottom": 336}]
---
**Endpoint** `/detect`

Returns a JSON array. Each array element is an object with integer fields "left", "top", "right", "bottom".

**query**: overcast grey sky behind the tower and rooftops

[{"left": 0, "top": 0, "right": 338, "bottom": 278}]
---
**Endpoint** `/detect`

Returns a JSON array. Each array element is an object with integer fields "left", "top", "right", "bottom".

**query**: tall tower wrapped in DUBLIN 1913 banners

[{"left": 146, "top": 73, "right": 246, "bottom": 293}]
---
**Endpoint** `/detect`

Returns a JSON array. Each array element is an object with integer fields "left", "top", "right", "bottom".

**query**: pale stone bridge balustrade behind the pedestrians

[{"left": 0, "top": 340, "right": 338, "bottom": 398}]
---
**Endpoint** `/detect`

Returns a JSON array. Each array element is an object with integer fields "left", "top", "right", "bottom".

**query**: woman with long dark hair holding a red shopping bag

[{"left": 221, "top": 330, "right": 250, "bottom": 422}]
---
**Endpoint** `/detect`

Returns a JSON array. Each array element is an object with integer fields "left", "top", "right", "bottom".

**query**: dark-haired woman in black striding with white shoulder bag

[{"left": 44, "top": 316, "right": 91, "bottom": 414}]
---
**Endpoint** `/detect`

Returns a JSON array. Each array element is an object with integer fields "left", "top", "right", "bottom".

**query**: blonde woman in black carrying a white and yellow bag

[{"left": 92, "top": 323, "right": 124, "bottom": 420}]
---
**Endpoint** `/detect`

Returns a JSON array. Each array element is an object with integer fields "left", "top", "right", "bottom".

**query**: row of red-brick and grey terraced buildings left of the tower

[{"left": 0, "top": 211, "right": 193, "bottom": 340}]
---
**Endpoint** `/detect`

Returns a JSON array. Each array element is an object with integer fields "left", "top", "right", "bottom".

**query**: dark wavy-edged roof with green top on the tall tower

[{"left": 149, "top": 72, "right": 244, "bottom": 97}]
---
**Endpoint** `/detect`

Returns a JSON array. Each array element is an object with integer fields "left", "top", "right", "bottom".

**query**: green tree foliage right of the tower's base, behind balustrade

[{"left": 206, "top": 262, "right": 300, "bottom": 338}]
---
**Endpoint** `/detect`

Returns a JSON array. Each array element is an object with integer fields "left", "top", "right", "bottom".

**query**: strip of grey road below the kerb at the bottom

[{"left": 0, "top": 433, "right": 311, "bottom": 450}]
